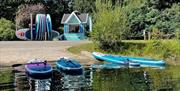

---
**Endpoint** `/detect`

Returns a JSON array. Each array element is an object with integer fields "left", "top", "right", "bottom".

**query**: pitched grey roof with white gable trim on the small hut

[{"left": 61, "top": 11, "right": 88, "bottom": 24}]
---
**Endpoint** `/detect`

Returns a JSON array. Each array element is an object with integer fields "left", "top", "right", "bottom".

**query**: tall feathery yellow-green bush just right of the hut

[{"left": 91, "top": 0, "right": 128, "bottom": 51}]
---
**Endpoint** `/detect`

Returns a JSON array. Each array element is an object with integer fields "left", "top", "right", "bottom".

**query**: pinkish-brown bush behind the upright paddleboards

[{"left": 16, "top": 4, "right": 45, "bottom": 28}]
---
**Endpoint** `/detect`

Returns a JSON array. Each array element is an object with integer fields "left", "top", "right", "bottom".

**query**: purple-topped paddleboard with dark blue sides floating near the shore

[{"left": 25, "top": 59, "right": 52, "bottom": 79}]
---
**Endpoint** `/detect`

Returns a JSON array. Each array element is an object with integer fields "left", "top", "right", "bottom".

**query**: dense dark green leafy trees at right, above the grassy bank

[{"left": 128, "top": 0, "right": 180, "bottom": 37}]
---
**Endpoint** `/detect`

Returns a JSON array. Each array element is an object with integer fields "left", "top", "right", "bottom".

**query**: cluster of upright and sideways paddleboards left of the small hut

[{"left": 16, "top": 14, "right": 59, "bottom": 40}]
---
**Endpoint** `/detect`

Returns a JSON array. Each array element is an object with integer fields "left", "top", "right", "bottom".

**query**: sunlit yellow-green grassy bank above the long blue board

[{"left": 68, "top": 40, "right": 180, "bottom": 64}]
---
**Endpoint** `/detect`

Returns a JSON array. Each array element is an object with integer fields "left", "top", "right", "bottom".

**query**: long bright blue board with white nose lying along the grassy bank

[{"left": 92, "top": 52, "right": 165, "bottom": 66}]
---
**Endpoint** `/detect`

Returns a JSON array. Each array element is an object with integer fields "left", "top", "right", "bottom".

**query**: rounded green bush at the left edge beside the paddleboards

[{"left": 0, "top": 18, "right": 15, "bottom": 41}]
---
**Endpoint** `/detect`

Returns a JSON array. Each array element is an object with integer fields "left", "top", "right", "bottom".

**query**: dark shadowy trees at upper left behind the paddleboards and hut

[{"left": 0, "top": 0, "right": 70, "bottom": 30}]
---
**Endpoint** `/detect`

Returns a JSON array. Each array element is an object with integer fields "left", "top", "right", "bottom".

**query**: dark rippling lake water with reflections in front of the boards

[{"left": 0, "top": 66, "right": 180, "bottom": 91}]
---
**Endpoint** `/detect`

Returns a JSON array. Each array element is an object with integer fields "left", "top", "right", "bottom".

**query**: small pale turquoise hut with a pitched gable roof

[{"left": 61, "top": 11, "right": 92, "bottom": 40}]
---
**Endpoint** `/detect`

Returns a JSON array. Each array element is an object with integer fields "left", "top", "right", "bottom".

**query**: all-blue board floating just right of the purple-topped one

[{"left": 56, "top": 57, "right": 83, "bottom": 75}]
